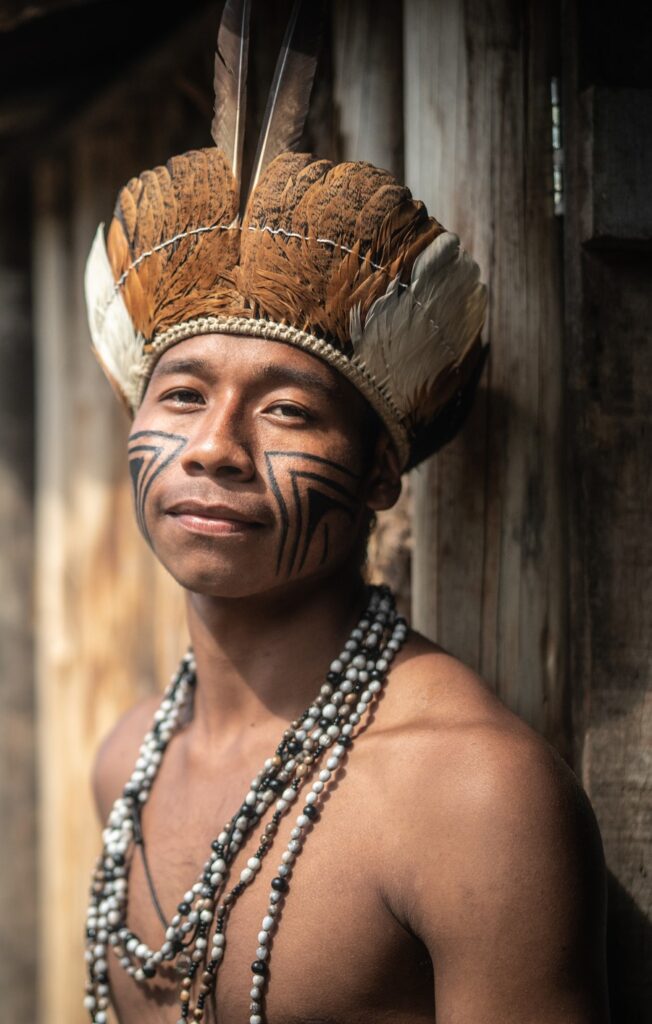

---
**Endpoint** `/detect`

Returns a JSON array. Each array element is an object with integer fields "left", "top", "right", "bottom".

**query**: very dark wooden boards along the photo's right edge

[{"left": 564, "top": 3, "right": 652, "bottom": 1011}]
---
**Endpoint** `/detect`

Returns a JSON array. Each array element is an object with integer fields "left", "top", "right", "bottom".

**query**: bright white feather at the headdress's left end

[{"left": 84, "top": 223, "right": 143, "bottom": 410}]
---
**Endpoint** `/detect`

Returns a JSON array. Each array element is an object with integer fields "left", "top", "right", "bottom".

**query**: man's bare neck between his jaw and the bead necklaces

[{"left": 187, "top": 569, "right": 364, "bottom": 746}]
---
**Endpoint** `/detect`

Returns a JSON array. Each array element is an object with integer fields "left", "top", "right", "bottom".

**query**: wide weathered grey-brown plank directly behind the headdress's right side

[{"left": 404, "top": 0, "right": 568, "bottom": 753}]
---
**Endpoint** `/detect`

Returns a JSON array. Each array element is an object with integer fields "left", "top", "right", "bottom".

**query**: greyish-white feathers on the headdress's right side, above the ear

[{"left": 349, "top": 231, "right": 486, "bottom": 418}]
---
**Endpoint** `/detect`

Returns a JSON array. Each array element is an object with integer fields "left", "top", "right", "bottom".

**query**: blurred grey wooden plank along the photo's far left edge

[{"left": 0, "top": 164, "right": 37, "bottom": 1021}]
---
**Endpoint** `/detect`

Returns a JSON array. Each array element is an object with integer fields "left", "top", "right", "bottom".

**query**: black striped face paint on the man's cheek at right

[{"left": 265, "top": 452, "right": 360, "bottom": 575}]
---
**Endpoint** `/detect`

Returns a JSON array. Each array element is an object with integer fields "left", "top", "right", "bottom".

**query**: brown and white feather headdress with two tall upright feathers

[{"left": 85, "top": 0, "right": 488, "bottom": 468}]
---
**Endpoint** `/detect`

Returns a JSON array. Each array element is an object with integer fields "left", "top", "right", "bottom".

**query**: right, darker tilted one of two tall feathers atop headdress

[{"left": 249, "top": 0, "right": 328, "bottom": 196}]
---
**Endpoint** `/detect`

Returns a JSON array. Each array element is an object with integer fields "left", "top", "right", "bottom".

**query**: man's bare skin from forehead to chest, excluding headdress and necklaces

[{"left": 89, "top": 335, "right": 607, "bottom": 1024}]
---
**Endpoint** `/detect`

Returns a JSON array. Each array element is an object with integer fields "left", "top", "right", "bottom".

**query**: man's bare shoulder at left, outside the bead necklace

[{"left": 91, "top": 694, "right": 161, "bottom": 824}]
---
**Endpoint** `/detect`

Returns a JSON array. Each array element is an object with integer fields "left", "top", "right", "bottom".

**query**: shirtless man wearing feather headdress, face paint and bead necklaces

[{"left": 86, "top": 4, "right": 607, "bottom": 1024}]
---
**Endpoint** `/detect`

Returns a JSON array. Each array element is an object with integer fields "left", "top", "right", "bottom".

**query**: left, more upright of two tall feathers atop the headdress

[{"left": 211, "top": 0, "right": 251, "bottom": 190}]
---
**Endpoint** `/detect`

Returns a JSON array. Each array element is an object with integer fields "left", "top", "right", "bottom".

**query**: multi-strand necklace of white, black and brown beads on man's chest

[{"left": 84, "top": 587, "right": 407, "bottom": 1024}]
